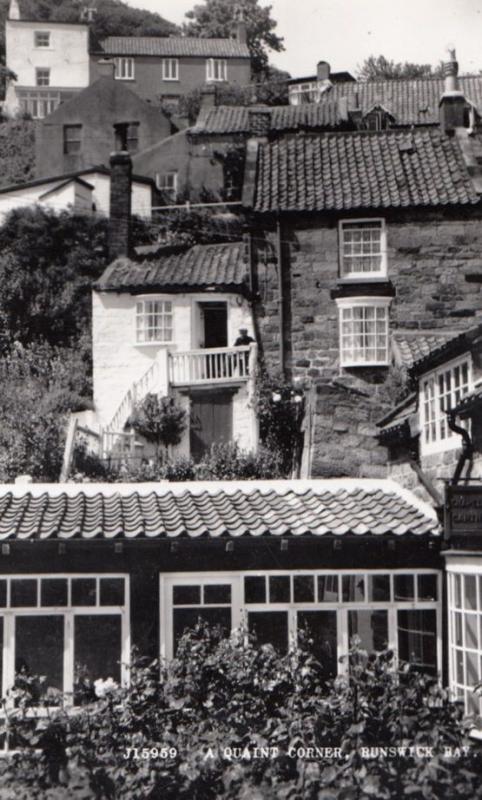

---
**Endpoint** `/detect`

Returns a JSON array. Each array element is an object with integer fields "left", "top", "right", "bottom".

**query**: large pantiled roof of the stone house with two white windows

[{"left": 253, "top": 128, "right": 478, "bottom": 212}]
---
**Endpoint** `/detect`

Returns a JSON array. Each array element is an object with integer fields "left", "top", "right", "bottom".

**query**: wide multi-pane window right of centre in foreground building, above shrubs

[{"left": 161, "top": 570, "right": 441, "bottom": 678}]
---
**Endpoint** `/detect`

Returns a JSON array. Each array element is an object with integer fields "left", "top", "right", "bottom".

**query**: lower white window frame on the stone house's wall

[{"left": 336, "top": 296, "right": 392, "bottom": 367}]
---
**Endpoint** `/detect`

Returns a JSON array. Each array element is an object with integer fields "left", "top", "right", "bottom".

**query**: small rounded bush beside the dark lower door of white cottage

[{"left": 127, "top": 393, "right": 187, "bottom": 456}]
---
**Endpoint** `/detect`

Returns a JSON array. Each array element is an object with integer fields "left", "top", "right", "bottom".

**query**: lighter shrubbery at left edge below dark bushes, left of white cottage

[{"left": 0, "top": 343, "right": 91, "bottom": 482}]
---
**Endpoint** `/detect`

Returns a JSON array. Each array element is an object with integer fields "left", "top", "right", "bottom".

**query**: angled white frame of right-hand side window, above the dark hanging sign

[{"left": 419, "top": 353, "right": 473, "bottom": 456}]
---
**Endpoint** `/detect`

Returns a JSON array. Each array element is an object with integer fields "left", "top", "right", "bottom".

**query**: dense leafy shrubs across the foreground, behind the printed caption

[{"left": 0, "top": 624, "right": 482, "bottom": 800}]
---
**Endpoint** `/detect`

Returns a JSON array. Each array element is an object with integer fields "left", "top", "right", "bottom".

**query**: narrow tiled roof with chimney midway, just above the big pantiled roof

[{"left": 191, "top": 102, "right": 348, "bottom": 135}]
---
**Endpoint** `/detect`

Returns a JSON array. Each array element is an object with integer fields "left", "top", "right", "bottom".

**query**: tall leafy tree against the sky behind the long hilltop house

[{"left": 183, "top": 0, "right": 284, "bottom": 78}]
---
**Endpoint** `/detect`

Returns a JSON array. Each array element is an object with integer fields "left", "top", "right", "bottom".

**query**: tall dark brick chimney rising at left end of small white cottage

[{"left": 109, "top": 150, "right": 132, "bottom": 261}]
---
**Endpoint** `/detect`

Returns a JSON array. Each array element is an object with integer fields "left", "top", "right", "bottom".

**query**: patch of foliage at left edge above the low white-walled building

[{"left": 0, "top": 119, "right": 36, "bottom": 186}]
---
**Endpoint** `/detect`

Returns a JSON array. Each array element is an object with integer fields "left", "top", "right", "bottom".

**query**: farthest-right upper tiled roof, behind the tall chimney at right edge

[{"left": 320, "top": 75, "right": 482, "bottom": 125}]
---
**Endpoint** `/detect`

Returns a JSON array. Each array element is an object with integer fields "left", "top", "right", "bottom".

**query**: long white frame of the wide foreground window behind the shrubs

[{"left": 159, "top": 567, "right": 442, "bottom": 675}]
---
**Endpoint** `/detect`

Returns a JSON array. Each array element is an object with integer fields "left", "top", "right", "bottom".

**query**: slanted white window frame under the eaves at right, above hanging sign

[{"left": 418, "top": 351, "right": 474, "bottom": 456}]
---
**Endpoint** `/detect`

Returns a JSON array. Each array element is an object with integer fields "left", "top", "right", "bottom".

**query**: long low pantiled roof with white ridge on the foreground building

[{"left": 0, "top": 479, "right": 439, "bottom": 540}]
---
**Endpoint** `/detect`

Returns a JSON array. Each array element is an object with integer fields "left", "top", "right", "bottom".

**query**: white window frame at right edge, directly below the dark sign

[{"left": 446, "top": 556, "right": 482, "bottom": 738}]
